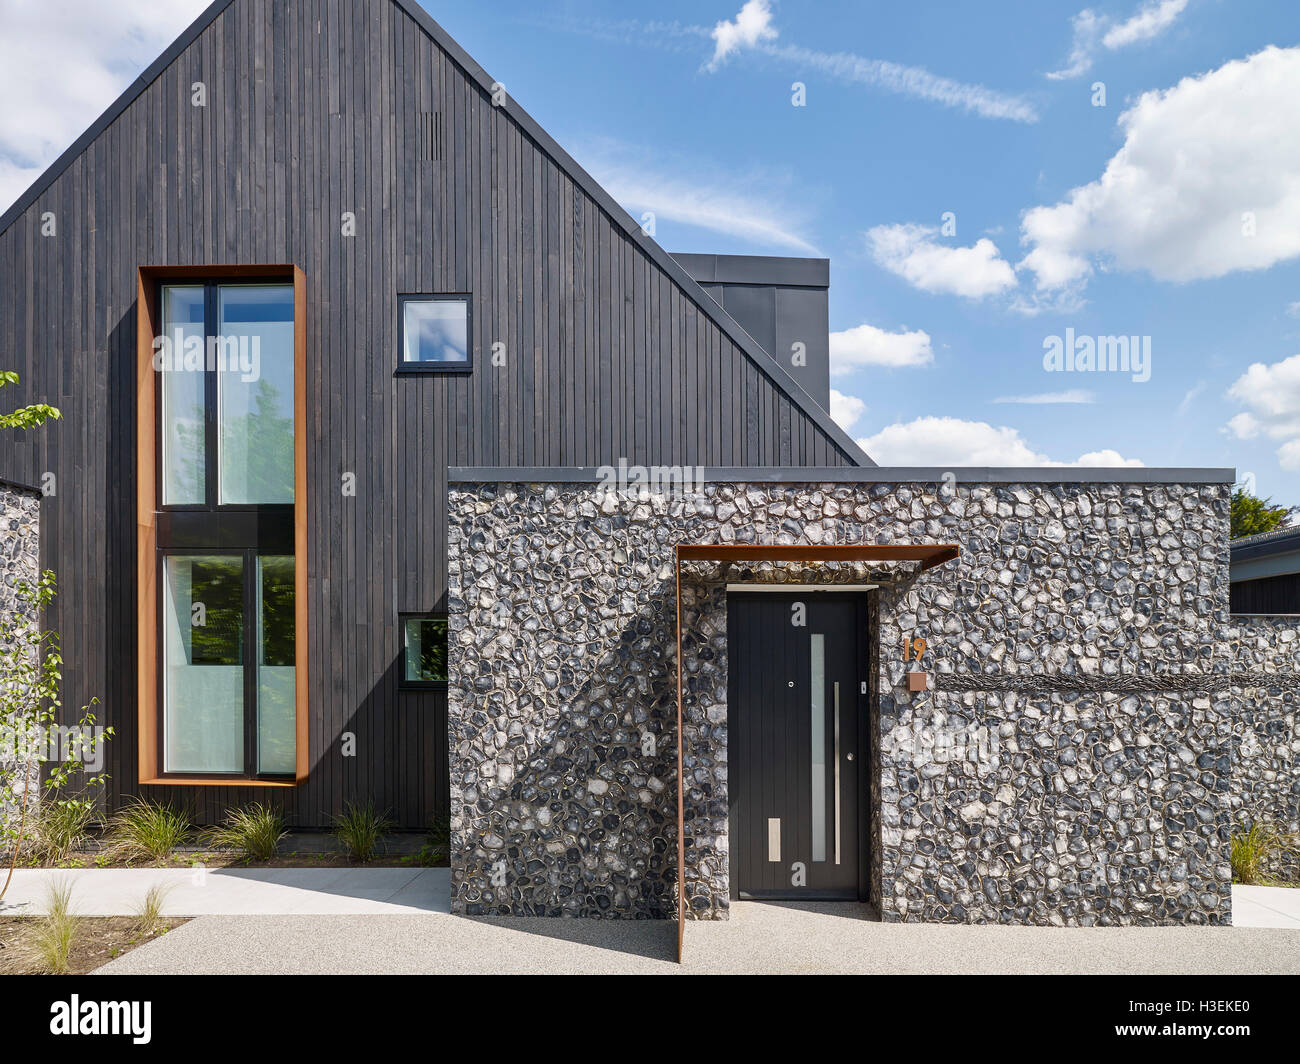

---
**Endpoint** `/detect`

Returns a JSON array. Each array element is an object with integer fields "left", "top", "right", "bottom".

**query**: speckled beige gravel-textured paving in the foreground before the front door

[{"left": 100, "top": 901, "right": 1300, "bottom": 974}]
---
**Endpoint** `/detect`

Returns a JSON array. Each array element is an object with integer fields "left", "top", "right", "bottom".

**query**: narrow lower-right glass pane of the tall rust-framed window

[{"left": 257, "top": 557, "right": 298, "bottom": 775}]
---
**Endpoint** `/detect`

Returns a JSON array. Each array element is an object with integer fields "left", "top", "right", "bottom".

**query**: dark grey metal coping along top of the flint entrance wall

[{"left": 447, "top": 463, "right": 1236, "bottom": 485}]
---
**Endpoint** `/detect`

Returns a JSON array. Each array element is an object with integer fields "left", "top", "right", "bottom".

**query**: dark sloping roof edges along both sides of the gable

[{"left": 0, "top": 0, "right": 876, "bottom": 466}]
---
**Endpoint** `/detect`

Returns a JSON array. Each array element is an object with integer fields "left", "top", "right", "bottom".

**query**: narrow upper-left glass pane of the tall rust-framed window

[{"left": 155, "top": 285, "right": 207, "bottom": 506}]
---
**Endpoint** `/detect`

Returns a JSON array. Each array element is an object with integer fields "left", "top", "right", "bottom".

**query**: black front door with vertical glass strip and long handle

[{"left": 727, "top": 592, "right": 867, "bottom": 899}]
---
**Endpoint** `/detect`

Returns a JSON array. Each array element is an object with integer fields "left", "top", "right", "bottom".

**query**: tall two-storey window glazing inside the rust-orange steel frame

[{"left": 155, "top": 278, "right": 300, "bottom": 782}]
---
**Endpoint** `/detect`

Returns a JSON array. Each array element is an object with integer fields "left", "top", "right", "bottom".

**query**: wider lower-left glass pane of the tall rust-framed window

[{"left": 163, "top": 555, "right": 244, "bottom": 774}]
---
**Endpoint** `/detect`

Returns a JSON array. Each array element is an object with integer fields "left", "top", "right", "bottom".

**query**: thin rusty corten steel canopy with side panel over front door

[{"left": 673, "top": 544, "right": 962, "bottom": 963}]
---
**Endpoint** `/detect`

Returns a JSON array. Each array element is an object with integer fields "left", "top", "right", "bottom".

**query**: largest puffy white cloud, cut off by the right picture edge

[{"left": 1019, "top": 47, "right": 1300, "bottom": 291}]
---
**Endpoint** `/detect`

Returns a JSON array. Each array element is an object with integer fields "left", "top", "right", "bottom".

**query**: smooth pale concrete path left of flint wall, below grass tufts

[{"left": 0, "top": 868, "right": 450, "bottom": 916}]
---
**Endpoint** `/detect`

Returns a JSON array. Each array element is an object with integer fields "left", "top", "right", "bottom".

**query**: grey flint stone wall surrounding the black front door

[{"left": 449, "top": 484, "right": 1234, "bottom": 925}]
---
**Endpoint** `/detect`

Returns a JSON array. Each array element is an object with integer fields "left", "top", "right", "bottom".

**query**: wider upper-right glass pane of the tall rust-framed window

[{"left": 215, "top": 285, "right": 294, "bottom": 505}]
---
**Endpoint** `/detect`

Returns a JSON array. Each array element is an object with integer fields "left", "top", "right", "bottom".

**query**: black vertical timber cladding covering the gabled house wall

[{"left": 0, "top": 0, "right": 867, "bottom": 827}]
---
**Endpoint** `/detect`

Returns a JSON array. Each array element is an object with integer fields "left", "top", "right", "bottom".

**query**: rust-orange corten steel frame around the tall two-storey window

[{"left": 135, "top": 264, "right": 311, "bottom": 787}]
